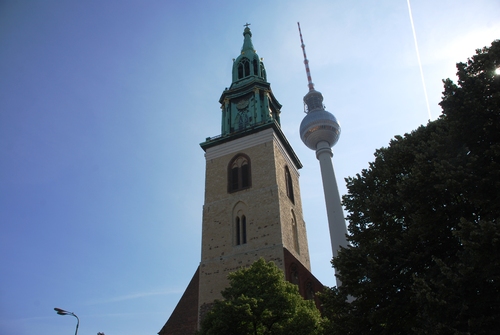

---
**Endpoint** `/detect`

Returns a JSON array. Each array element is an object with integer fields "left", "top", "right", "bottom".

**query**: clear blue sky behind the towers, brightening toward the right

[{"left": 0, "top": 0, "right": 500, "bottom": 335}]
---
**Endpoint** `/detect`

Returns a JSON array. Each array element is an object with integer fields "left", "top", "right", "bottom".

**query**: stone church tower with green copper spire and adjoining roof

[{"left": 159, "top": 24, "right": 322, "bottom": 335}]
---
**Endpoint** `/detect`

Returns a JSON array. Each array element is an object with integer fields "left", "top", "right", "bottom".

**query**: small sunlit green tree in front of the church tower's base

[{"left": 198, "top": 258, "right": 322, "bottom": 335}]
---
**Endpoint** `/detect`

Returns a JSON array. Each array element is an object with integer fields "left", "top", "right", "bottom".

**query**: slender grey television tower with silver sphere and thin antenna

[{"left": 297, "top": 22, "right": 347, "bottom": 286}]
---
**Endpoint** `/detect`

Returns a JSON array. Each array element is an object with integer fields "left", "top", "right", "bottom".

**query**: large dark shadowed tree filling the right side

[{"left": 322, "top": 40, "right": 500, "bottom": 334}]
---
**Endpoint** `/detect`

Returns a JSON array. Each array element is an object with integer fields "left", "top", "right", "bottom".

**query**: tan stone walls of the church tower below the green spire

[{"left": 199, "top": 128, "right": 310, "bottom": 307}]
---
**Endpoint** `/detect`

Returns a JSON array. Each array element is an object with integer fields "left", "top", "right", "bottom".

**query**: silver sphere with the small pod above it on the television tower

[{"left": 300, "top": 89, "right": 340, "bottom": 150}]
